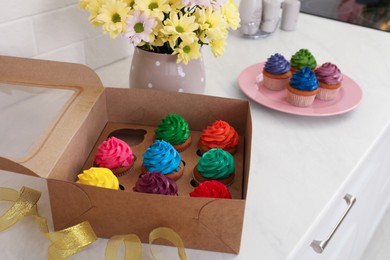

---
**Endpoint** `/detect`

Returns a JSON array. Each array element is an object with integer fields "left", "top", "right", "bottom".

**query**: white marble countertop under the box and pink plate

[{"left": 2, "top": 14, "right": 390, "bottom": 260}]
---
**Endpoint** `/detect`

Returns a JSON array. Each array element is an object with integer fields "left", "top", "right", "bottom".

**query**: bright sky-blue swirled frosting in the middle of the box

[{"left": 142, "top": 140, "right": 181, "bottom": 174}]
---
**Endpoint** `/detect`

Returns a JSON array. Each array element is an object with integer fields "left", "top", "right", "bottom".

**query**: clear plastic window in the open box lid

[{"left": 0, "top": 83, "right": 76, "bottom": 160}]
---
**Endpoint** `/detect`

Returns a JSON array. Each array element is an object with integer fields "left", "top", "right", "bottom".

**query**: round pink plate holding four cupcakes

[{"left": 238, "top": 62, "right": 363, "bottom": 116}]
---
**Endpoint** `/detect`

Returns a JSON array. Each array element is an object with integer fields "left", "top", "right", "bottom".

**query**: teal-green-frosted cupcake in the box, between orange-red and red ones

[{"left": 193, "top": 148, "right": 235, "bottom": 185}]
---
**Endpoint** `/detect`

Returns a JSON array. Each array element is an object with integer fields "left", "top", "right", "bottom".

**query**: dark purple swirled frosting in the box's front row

[{"left": 133, "top": 172, "right": 177, "bottom": 195}]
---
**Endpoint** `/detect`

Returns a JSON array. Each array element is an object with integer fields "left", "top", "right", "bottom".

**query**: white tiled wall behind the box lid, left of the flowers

[{"left": 0, "top": 0, "right": 133, "bottom": 69}]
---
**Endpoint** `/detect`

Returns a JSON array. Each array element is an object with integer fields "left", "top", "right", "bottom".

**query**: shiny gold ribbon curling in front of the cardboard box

[{"left": 0, "top": 187, "right": 187, "bottom": 260}]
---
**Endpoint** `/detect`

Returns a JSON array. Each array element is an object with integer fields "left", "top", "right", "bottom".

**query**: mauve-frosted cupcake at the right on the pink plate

[{"left": 314, "top": 62, "right": 343, "bottom": 100}]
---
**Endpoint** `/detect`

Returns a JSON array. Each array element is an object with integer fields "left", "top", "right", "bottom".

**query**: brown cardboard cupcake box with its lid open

[{"left": 0, "top": 56, "right": 252, "bottom": 254}]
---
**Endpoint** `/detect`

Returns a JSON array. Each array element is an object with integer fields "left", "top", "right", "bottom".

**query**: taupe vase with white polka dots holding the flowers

[{"left": 130, "top": 48, "right": 206, "bottom": 93}]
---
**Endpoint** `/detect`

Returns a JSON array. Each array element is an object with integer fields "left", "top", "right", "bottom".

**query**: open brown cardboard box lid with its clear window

[{"left": 0, "top": 56, "right": 104, "bottom": 178}]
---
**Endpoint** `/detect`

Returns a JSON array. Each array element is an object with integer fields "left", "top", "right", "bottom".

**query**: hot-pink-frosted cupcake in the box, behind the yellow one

[{"left": 94, "top": 137, "right": 135, "bottom": 176}]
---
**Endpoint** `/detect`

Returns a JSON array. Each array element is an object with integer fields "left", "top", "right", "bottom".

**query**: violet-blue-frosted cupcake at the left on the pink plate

[{"left": 263, "top": 53, "right": 291, "bottom": 90}]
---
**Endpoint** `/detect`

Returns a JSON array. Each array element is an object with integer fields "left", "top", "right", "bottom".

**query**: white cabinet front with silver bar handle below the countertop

[{"left": 288, "top": 126, "right": 390, "bottom": 260}]
